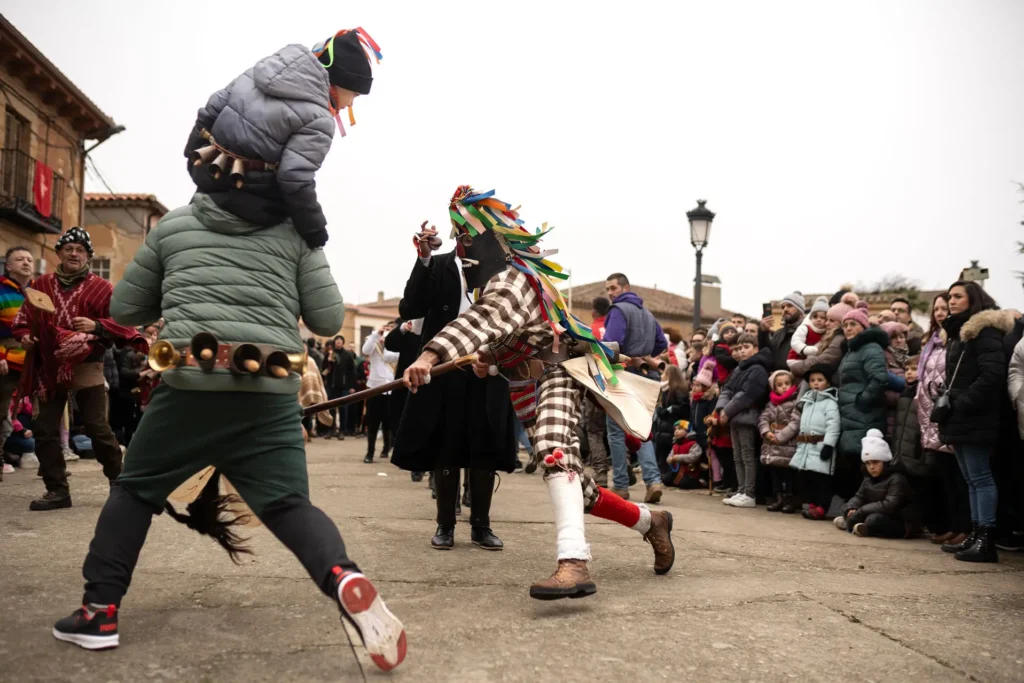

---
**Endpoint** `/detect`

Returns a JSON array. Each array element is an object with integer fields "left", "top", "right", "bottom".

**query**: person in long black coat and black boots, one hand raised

[{"left": 394, "top": 223, "right": 516, "bottom": 550}]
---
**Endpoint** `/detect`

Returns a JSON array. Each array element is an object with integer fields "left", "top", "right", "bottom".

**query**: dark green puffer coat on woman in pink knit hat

[{"left": 839, "top": 328, "right": 889, "bottom": 458}]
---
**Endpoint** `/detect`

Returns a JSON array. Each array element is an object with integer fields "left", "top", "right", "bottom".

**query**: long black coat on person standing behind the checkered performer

[{"left": 391, "top": 252, "right": 518, "bottom": 472}]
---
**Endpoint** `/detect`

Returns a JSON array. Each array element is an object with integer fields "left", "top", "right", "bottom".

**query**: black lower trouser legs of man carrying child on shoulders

[{"left": 82, "top": 484, "right": 358, "bottom": 605}]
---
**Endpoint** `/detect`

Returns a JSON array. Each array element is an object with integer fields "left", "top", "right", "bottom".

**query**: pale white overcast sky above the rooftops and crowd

[{"left": 3, "top": 0, "right": 1024, "bottom": 313}]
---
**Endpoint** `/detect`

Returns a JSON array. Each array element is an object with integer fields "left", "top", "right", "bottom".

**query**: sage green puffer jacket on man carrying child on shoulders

[{"left": 111, "top": 194, "right": 345, "bottom": 393}]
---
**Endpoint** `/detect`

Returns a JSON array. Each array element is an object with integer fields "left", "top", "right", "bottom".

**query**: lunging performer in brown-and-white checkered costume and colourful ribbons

[{"left": 404, "top": 185, "right": 675, "bottom": 600}]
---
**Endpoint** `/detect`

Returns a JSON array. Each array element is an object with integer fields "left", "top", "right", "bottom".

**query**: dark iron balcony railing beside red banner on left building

[{"left": 0, "top": 150, "right": 66, "bottom": 234}]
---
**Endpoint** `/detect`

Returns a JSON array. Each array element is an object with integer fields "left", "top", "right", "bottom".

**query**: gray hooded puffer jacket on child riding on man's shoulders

[{"left": 185, "top": 45, "right": 335, "bottom": 248}]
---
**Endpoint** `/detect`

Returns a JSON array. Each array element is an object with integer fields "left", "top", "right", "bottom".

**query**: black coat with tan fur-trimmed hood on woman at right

[{"left": 939, "top": 310, "right": 1014, "bottom": 445}]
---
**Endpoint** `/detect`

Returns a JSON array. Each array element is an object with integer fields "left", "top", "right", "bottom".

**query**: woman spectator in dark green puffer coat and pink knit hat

[{"left": 836, "top": 308, "right": 889, "bottom": 498}]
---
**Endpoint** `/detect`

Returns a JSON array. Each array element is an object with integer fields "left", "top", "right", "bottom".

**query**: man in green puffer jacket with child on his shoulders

[{"left": 53, "top": 30, "right": 406, "bottom": 670}]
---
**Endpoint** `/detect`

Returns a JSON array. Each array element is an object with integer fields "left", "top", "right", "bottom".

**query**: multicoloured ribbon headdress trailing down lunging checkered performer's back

[{"left": 449, "top": 185, "right": 618, "bottom": 390}]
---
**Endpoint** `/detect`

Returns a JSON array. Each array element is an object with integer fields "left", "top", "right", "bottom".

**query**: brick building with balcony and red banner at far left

[{"left": 0, "top": 15, "right": 123, "bottom": 272}]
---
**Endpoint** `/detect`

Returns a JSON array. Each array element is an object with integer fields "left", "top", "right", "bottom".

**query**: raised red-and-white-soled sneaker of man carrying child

[{"left": 334, "top": 567, "right": 406, "bottom": 671}]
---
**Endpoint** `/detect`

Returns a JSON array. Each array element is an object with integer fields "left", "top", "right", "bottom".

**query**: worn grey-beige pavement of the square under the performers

[{"left": 0, "top": 439, "right": 1024, "bottom": 683}]
